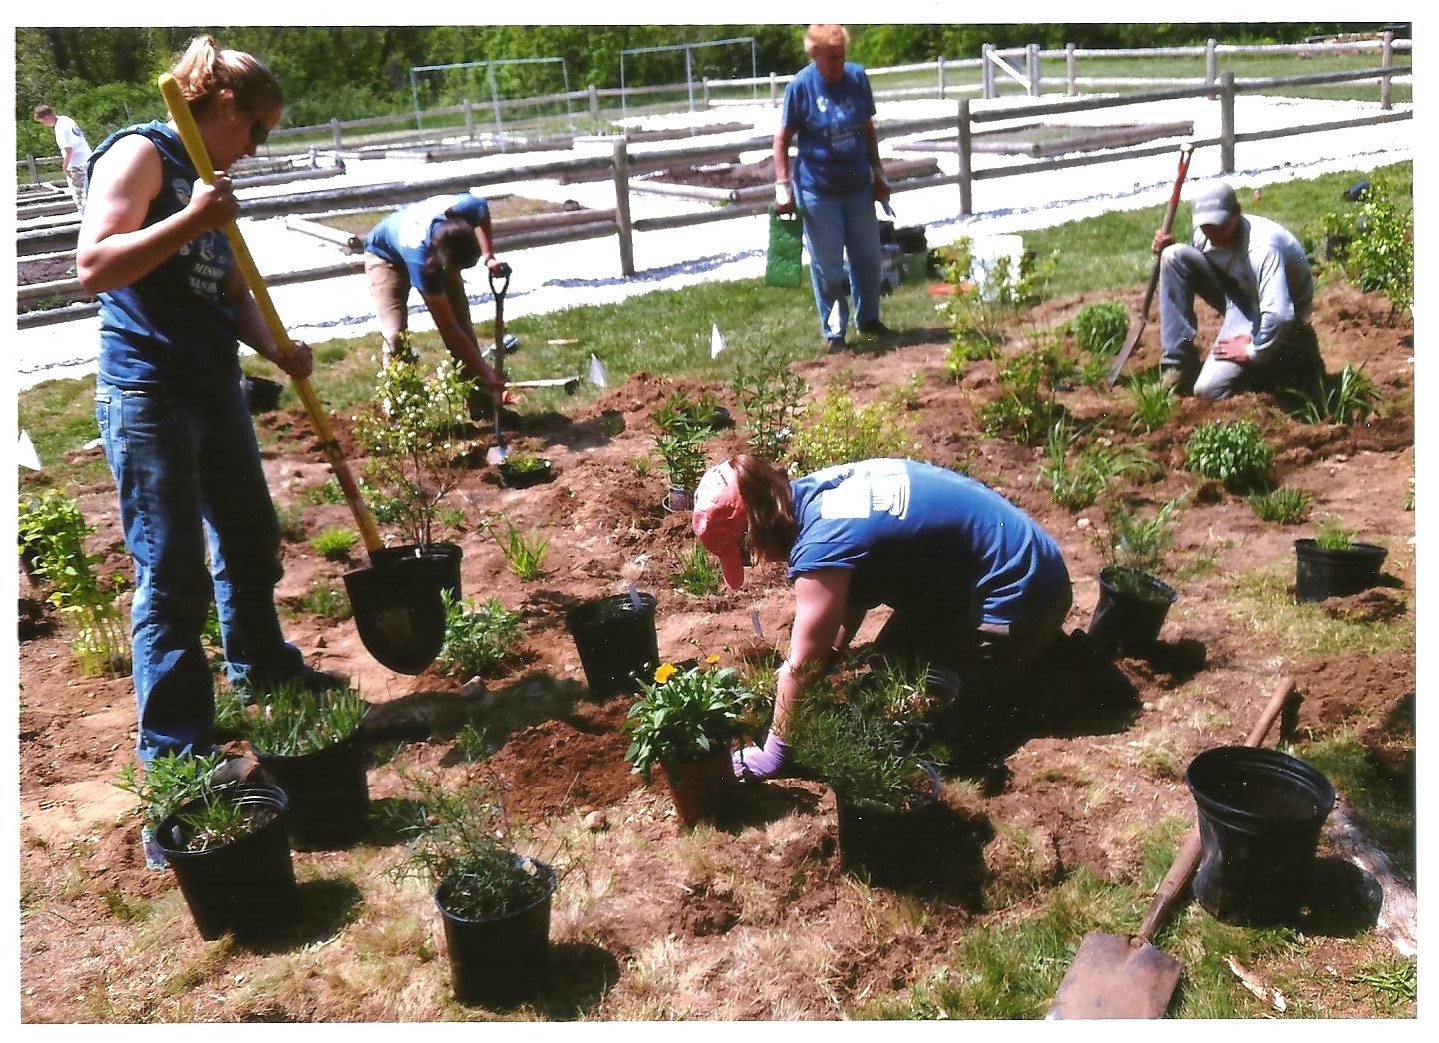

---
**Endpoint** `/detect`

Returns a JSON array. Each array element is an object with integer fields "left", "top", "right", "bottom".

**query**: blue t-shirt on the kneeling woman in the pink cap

[{"left": 790, "top": 460, "right": 1069, "bottom": 624}]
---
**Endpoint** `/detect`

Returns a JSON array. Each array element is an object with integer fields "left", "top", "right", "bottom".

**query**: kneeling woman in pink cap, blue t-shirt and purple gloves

[{"left": 692, "top": 453, "right": 1072, "bottom": 778}]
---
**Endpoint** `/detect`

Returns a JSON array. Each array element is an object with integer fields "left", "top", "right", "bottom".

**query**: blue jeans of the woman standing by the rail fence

[{"left": 794, "top": 186, "right": 882, "bottom": 341}]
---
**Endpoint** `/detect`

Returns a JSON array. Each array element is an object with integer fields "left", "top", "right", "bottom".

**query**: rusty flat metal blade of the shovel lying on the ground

[{"left": 1049, "top": 934, "right": 1181, "bottom": 1020}]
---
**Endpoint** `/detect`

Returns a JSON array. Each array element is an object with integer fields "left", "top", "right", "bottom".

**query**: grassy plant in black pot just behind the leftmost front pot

[{"left": 223, "top": 685, "right": 370, "bottom": 849}]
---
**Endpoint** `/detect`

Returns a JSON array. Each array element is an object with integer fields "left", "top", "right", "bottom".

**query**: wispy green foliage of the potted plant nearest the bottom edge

[{"left": 387, "top": 765, "right": 551, "bottom": 919}]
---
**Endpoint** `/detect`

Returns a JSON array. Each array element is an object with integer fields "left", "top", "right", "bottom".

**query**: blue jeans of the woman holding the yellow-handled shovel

[{"left": 95, "top": 380, "right": 305, "bottom": 761}]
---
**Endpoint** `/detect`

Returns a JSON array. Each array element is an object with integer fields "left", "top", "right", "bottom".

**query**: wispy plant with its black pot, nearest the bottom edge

[{"left": 390, "top": 770, "right": 558, "bottom": 1006}]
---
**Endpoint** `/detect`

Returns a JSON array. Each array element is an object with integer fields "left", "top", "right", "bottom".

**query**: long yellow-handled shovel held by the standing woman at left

[{"left": 160, "top": 73, "right": 445, "bottom": 673}]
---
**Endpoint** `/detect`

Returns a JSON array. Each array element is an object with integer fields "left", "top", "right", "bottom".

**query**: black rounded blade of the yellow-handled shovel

[{"left": 345, "top": 558, "right": 445, "bottom": 675}]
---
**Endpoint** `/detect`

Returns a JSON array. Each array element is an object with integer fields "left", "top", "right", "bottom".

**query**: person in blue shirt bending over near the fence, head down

[{"left": 364, "top": 191, "right": 509, "bottom": 416}]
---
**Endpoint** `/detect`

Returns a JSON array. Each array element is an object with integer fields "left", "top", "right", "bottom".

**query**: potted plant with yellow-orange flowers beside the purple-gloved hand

[{"left": 625, "top": 656, "right": 754, "bottom": 824}]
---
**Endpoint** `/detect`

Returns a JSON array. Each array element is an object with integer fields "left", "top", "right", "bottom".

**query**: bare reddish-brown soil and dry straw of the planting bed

[{"left": 19, "top": 269, "right": 1415, "bottom": 1023}]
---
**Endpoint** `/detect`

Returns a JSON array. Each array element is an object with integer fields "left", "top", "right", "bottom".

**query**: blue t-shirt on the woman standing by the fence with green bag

[{"left": 783, "top": 62, "right": 875, "bottom": 196}]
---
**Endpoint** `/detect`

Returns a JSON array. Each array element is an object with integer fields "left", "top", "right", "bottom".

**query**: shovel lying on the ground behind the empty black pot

[{"left": 1049, "top": 678, "right": 1294, "bottom": 1020}]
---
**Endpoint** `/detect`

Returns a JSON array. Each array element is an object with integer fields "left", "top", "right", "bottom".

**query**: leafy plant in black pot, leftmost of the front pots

[{"left": 119, "top": 754, "right": 299, "bottom": 939}]
